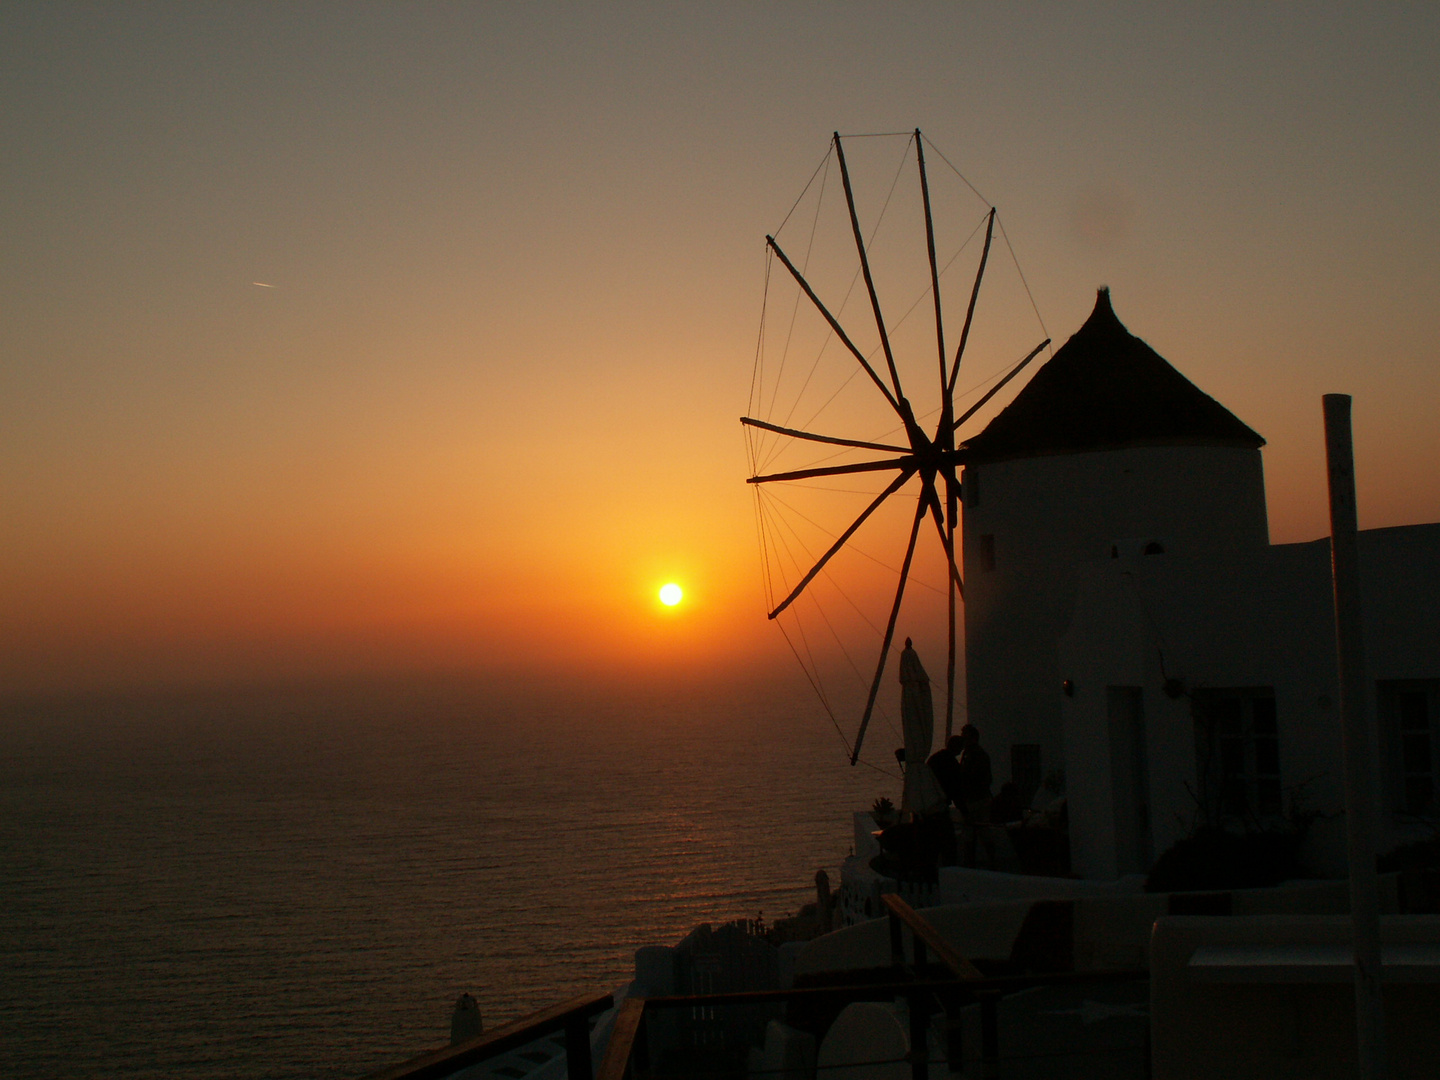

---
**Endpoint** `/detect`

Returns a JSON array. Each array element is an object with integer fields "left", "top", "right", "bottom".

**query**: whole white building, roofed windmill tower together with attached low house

[{"left": 963, "top": 289, "right": 1440, "bottom": 877}]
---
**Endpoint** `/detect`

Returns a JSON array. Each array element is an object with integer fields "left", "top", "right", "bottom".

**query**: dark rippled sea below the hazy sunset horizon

[{"left": 0, "top": 680, "right": 899, "bottom": 1080}]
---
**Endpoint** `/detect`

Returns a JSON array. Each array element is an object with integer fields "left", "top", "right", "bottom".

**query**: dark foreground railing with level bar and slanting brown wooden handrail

[{"left": 596, "top": 894, "right": 1149, "bottom": 1080}]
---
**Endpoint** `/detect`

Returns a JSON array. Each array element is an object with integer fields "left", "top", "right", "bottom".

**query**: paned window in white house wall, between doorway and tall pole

[{"left": 1194, "top": 687, "right": 1284, "bottom": 825}]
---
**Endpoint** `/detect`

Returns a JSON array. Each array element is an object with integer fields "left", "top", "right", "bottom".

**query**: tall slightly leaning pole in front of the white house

[{"left": 1323, "top": 393, "right": 1385, "bottom": 1080}]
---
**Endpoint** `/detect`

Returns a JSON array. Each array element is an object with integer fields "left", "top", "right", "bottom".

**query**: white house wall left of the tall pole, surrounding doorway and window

[{"left": 1060, "top": 543, "right": 1339, "bottom": 877}]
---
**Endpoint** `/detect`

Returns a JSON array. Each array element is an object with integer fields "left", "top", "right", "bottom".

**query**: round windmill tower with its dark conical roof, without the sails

[{"left": 959, "top": 288, "right": 1269, "bottom": 812}]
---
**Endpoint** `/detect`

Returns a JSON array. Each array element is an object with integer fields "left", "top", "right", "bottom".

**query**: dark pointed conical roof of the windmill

[{"left": 963, "top": 288, "right": 1264, "bottom": 461}]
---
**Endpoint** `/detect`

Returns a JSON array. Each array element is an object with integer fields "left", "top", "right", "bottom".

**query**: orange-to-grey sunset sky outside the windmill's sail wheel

[{"left": 0, "top": 3, "right": 1440, "bottom": 693}]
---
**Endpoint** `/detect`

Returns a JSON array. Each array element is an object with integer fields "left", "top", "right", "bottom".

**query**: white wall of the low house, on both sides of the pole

[{"left": 1057, "top": 524, "right": 1440, "bottom": 877}]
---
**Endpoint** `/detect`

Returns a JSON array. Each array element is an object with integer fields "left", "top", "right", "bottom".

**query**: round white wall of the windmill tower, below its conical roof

[{"left": 962, "top": 446, "right": 1269, "bottom": 782}]
